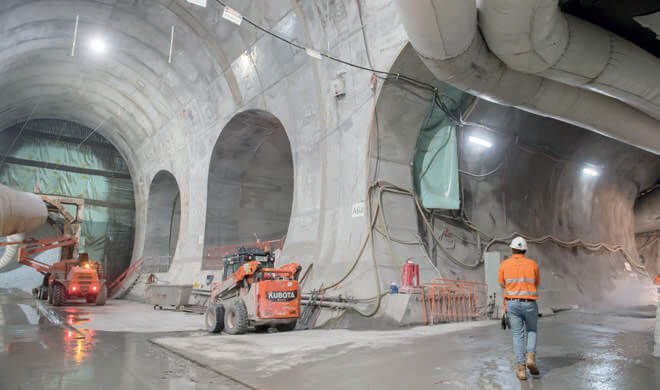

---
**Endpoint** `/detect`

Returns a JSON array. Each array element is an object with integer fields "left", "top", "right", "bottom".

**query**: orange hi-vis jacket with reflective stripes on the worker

[{"left": 497, "top": 253, "right": 541, "bottom": 300}]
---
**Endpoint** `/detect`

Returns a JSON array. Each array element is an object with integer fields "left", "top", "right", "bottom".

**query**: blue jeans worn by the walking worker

[{"left": 506, "top": 301, "right": 539, "bottom": 364}]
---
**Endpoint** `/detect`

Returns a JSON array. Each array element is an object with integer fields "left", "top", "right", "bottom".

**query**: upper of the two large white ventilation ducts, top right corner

[{"left": 479, "top": 0, "right": 660, "bottom": 119}]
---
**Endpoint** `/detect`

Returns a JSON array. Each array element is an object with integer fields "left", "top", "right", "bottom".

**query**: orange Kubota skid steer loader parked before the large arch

[{"left": 205, "top": 248, "right": 302, "bottom": 334}]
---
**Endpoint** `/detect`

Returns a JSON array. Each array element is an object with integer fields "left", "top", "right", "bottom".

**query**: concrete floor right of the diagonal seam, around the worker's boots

[{"left": 153, "top": 312, "right": 660, "bottom": 389}]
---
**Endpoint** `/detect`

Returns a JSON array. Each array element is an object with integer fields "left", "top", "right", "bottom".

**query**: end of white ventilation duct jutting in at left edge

[{"left": 0, "top": 184, "right": 48, "bottom": 237}]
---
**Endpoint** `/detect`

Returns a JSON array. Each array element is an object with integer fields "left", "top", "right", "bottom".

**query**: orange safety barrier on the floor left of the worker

[{"left": 421, "top": 279, "right": 488, "bottom": 325}]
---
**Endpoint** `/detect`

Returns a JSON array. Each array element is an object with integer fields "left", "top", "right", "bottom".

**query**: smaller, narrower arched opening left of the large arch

[{"left": 142, "top": 171, "right": 181, "bottom": 273}]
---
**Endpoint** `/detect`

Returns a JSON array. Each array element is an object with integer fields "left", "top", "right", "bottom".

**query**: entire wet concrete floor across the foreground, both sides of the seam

[{"left": 0, "top": 289, "right": 660, "bottom": 390}]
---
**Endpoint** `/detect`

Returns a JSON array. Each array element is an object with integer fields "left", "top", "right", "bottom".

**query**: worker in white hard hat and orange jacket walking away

[{"left": 498, "top": 237, "right": 540, "bottom": 380}]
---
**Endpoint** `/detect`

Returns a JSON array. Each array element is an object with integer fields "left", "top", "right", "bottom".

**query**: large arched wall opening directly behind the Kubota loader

[{"left": 202, "top": 110, "right": 293, "bottom": 269}]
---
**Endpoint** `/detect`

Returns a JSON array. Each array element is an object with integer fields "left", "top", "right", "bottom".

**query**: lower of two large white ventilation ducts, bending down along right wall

[{"left": 394, "top": 0, "right": 660, "bottom": 154}]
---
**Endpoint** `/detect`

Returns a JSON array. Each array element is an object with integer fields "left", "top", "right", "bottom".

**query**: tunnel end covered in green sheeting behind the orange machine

[{"left": 0, "top": 120, "right": 135, "bottom": 280}]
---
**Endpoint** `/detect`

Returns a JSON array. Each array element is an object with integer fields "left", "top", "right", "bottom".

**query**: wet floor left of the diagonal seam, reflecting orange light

[{"left": 0, "top": 289, "right": 244, "bottom": 390}]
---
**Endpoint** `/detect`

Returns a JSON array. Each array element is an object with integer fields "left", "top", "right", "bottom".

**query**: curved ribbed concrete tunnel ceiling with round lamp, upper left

[{"left": 0, "top": 0, "right": 263, "bottom": 165}]
